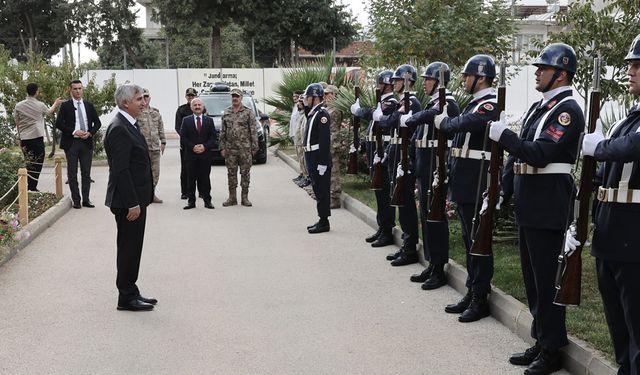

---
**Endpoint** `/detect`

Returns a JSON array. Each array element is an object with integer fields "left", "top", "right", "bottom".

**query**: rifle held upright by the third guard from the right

[{"left": 425, "top": 67, "right": 447, "bottom": 222}]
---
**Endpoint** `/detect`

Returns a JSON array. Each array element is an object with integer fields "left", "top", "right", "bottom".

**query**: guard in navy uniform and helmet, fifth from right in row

[{"left": 372, "top": 64, "right": 421, "bottom": 267}]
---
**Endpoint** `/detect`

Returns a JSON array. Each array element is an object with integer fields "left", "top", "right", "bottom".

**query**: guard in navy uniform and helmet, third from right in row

[{"left": 434, "top": 55, "right": 498, "bottom": 322}]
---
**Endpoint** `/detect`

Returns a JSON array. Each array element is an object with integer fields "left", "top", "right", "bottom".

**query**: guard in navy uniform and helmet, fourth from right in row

[{"left": 401, "top": 62, "right": 460, "bottom": 290}]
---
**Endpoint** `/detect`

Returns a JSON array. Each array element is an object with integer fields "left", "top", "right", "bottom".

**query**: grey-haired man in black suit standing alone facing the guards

[{"left": 104, "top": 84, "right": 158, "bottom": 311}]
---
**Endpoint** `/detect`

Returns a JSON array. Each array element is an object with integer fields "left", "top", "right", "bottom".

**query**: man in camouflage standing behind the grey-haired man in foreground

[{"left": 138, "top": 89, "right": 167, "bottom": 203}]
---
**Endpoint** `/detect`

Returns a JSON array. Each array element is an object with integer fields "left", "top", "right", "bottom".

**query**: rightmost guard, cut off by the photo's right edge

[{"left": 567, "top": 35, "right": 640, "bottom": 375}]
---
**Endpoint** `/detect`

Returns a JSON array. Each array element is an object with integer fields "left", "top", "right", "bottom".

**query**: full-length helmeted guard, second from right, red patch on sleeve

[{"left": 489, "top": 43, "right": 585, "bottom": 375}]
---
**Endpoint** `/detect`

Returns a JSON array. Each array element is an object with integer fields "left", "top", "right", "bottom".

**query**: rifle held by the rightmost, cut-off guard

[{"left": 553, "top": 57, "right": 602, "bottom": 306}]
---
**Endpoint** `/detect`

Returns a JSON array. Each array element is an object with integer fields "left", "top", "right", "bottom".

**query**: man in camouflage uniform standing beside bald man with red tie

[{"left": 220, "top": 88, "right": 258, "bottom": 207}]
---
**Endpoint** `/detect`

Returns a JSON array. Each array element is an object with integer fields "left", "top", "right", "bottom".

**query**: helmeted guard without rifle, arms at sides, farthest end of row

[{"left": 303, "top": 83, "right": 331, "bottom": 233}]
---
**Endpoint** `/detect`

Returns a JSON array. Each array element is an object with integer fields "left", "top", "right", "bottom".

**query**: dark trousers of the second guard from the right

[{"left": 519, "top": 227, "right": 569, "bottom": 350}]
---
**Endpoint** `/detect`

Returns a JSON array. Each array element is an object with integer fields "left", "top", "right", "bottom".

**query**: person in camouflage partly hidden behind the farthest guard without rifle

[{"left": 324, "top": 85, "right": 342, "bottom": 209}]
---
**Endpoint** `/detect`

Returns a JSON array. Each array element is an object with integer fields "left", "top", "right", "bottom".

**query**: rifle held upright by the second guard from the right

[{"left": 469, "top": 60, "right": 507, "bottom": 256}]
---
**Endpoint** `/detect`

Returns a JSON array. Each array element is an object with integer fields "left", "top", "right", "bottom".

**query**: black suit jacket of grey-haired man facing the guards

[{"left": 104, "top": 113, "right": 153, "bottom": 208}]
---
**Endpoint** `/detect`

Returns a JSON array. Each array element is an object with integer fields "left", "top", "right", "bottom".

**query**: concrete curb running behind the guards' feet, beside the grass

[{"left": 273, "top": 149, "right": 617, "bottom": 375}]
